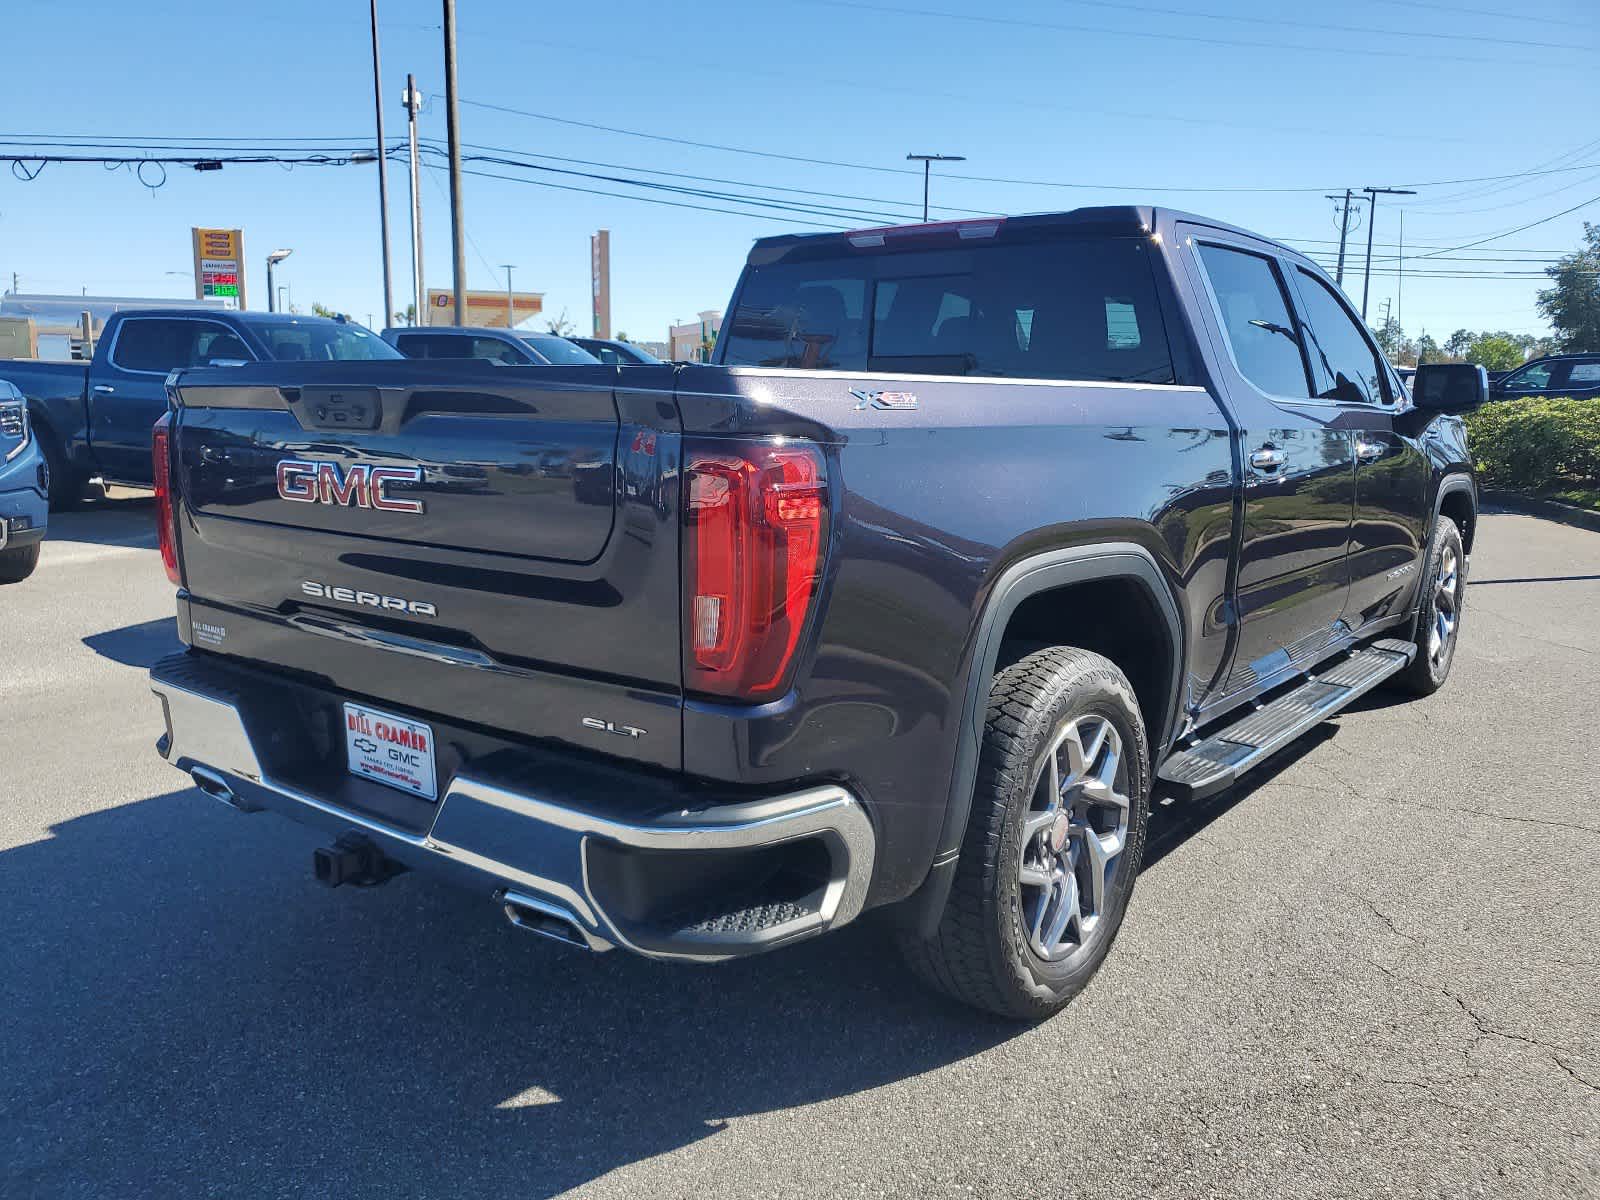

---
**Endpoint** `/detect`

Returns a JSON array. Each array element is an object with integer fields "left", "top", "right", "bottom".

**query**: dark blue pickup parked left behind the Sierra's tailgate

[{"left": 0, "top": 309, "right": 400, "bottom": 507}]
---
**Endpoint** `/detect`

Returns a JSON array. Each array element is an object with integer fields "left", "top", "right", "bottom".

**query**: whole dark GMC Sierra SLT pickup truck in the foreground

[{"left": 150, "top": 206, "right": 1486, "bottom": 1018}]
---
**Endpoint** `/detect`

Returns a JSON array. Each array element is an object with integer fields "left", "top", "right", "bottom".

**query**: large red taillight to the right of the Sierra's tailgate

[{"left": 683, "top": 442, "right": 827, "bottom": 699}]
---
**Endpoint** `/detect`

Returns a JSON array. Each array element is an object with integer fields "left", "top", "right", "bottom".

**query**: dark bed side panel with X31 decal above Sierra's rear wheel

[{"left": 678, "top": 366, "right": 1234, "bottom": 901}]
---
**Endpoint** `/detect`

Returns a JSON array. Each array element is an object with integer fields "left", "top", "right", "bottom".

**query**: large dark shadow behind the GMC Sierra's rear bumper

[{"left": 0, "top": 790, "right": 1019, "bottom": 1197}]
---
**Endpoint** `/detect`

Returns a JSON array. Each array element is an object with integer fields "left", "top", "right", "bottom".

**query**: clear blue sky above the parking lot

[{"left": 0, "top": 0, "right": 1600, "bottom": 339}]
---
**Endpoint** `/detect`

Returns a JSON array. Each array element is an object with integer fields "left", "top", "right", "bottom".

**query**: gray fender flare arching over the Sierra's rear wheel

[{"left": 907, "top": 542, "right": 1186, "bottom": 938}]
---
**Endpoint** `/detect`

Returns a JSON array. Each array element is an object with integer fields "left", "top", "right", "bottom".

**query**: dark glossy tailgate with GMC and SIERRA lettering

[{"left": 173, "top": 362, "right": 682, "bottom": 768}]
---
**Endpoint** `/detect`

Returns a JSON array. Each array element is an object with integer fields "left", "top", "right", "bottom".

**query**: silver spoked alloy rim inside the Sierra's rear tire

[{"left": 1018, "top": 715, "right": 1128, "bottom": 962}]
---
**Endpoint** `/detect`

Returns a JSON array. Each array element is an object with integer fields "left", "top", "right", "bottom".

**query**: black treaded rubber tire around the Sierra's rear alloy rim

[{"left": 901, "top": 646, "right": 1150, "bottom": 1021}]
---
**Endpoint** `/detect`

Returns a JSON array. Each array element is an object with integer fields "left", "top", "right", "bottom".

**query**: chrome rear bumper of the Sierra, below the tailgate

[{"left": 150, "top": 656, "right": 875, "bottom": 962}]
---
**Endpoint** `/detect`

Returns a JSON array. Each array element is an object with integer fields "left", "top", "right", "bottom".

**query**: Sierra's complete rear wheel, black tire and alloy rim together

[{"left": 902, "top": 646, "right": 1150, "bottom": 1021}]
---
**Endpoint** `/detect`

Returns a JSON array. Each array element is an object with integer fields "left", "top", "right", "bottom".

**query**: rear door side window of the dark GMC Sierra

[{"left": 1197, "top": 242, "right": 1310, "bottom": 400}]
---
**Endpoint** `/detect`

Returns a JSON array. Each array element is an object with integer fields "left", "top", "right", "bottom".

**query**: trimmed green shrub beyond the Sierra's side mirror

[{"left": 1467, "top": 398, "right": 1600, "bottom": 491}]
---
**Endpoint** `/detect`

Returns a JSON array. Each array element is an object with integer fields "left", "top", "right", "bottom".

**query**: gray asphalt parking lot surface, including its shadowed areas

[{"left": 0, "top": 501, "right": 1600, "bottom": 1198}]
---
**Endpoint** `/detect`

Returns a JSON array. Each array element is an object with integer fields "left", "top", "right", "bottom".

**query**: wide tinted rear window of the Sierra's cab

[{"left": 720, "top": 238, "right": 1173, "bottom": 382}]
